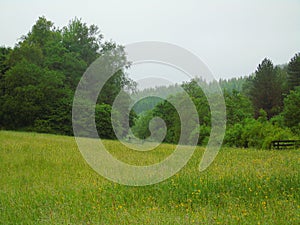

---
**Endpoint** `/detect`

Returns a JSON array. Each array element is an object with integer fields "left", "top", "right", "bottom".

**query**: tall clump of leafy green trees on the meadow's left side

[{"left": 0, "top": 17, "right": 134, "bottom": 135}]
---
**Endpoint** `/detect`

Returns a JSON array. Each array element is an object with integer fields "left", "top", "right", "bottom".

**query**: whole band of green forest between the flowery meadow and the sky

[{"left": 0, "top": 17, "right": 300, "bottom": 148}]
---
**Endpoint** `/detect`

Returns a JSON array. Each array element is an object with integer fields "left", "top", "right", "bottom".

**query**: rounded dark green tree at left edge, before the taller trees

[{"left": 2, "top": 60, "right": 65, "bottom": 129}]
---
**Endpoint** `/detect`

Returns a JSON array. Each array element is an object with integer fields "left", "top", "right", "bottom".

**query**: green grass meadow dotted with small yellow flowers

[{"left": 0, "top": 131, "right": 300, "bottom": 225}]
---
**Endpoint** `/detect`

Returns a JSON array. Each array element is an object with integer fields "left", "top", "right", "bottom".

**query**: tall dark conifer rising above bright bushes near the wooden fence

[{"left": 249, "top": 59, "right": 283, "bottom": 119}]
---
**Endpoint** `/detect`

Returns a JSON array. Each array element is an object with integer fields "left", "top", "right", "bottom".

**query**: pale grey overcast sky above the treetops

[{"left": 0, "top": 0, "right": 300, "bottom": 81}]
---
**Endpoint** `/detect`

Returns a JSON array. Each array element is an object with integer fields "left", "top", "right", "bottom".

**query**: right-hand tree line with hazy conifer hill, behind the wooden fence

[{"left": 133, "top": 53, "right": 300, "bottom": 148}]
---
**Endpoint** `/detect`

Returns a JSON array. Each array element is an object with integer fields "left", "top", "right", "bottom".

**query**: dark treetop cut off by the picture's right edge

[{"left": 288, "top": 53, "right": 300, "bottom": 90}]
